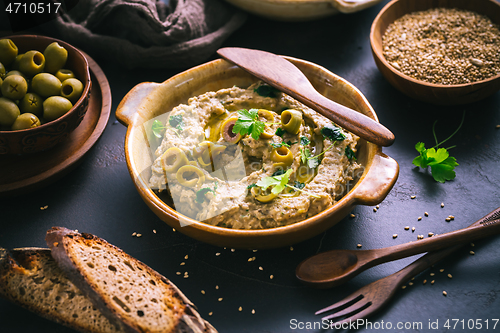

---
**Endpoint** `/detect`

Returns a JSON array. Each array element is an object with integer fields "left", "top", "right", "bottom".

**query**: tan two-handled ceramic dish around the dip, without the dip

[{"left": 116, "top": 57, "right": 399, "bottom": 249}]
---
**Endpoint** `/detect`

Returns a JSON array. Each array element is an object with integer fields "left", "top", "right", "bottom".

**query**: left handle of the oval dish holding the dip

[{"left": 116, "top": 82, "right": 160, "bottom": 126}]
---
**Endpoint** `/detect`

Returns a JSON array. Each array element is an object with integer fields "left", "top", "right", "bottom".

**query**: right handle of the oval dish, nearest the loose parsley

[{"left": 355, "top": 149, "right": 399, "bottom": 206}]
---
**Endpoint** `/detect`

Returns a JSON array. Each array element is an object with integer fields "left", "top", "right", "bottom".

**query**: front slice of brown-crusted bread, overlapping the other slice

[{"left": 46, "top": 227, "right": 217, "bottom": 333}]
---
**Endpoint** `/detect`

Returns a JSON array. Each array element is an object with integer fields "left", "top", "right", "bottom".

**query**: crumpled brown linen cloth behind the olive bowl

[{"left": 41, "top": 0, "right": 246, "bottom": 68}]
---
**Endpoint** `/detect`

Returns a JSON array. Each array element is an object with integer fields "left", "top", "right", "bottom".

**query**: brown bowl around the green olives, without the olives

[{"left": 0, "top": 35, "right": 91, "bottom": 154}]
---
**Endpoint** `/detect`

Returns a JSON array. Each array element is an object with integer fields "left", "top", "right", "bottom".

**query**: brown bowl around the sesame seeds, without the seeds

[{"left": 370, "top": 0, "right": 500, "bottom": 105}]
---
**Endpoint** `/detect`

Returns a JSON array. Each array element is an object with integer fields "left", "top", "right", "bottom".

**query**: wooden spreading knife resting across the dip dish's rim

[{"left": 217, "top": 47, "right": 394, "bottom": 147}]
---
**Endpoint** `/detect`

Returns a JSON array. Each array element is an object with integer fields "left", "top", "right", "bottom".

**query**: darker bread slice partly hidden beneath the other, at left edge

[{"left": 0, "top": 248, "right": 123, "bottom": 333}]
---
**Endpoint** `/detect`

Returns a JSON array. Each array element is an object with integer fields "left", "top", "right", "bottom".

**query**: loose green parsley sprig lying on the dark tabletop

[{"left": 412, "top": 112, "right": 465, "bottom": 183}]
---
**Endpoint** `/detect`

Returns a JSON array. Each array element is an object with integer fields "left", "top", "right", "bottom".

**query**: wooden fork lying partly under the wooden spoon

[{"left": 315, "top": 208, "right": 500, "bottom": 327}]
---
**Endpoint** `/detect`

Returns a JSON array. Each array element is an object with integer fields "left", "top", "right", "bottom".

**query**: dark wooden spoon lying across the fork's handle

[{"left": 296, "top": 208, "right": 500, "bottom": 288}]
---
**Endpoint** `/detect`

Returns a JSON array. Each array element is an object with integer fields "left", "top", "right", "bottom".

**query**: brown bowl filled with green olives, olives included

[{"left": 0, "top": 35, "right": 91, "bottom": 154}]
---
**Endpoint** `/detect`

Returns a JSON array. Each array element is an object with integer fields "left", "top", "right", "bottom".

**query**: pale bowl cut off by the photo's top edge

[{"left": 226, "top": 0, "right": 380, "bottom": 21}]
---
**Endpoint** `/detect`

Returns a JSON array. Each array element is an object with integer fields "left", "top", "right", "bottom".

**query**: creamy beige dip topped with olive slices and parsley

[{"left": 149, "top": 82, "right": 361, "bottom": 229}]
